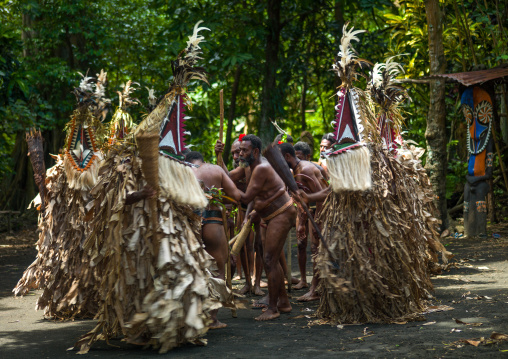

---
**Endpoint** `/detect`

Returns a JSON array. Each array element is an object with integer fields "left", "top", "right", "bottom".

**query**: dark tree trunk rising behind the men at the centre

[{"left": 258, "top": 0, "right": 282, "bottom": 145}]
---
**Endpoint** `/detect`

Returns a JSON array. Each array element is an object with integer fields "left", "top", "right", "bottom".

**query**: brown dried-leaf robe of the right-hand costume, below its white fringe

[{"left": 316, "top": 145, "right": 449, "bottom": 323}]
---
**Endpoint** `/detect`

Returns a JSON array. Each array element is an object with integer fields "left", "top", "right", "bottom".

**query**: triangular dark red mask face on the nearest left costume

[{"left": 159, "top": 95, "right": 187, "bottom": 158}]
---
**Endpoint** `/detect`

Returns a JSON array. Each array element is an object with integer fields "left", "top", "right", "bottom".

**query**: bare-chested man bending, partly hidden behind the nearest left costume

[{"left": 185, "top": 151, "right": 243, "bottom": 329}]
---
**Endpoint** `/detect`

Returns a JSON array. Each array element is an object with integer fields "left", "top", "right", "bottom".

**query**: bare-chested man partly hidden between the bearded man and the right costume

[{"left": 279, "top": 143, "right": 325, "bottom": 301}]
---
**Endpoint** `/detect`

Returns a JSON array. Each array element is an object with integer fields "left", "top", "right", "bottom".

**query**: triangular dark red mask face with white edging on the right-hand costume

[{"left": 331, "top": 88, "right": 363, "bottom": 154}]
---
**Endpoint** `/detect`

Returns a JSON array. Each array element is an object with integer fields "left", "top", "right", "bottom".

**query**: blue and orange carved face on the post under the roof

[{"left": 461, "top": 86, "right": 494, "bottom": 154}]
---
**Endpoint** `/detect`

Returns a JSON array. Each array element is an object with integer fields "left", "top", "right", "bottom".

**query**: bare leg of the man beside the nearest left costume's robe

[{"left": 202, "top": 224, "right": 228, "bottom": 329}]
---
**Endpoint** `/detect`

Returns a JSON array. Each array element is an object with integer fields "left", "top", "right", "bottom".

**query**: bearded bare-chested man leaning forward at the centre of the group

[{"left": 240, "top": 135, "right": 296, "bottom": 320}]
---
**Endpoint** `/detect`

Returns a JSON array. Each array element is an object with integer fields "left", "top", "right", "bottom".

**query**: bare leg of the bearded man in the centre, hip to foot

[{"left": 256, "top": 206, "right": 296, "bottom": 320}]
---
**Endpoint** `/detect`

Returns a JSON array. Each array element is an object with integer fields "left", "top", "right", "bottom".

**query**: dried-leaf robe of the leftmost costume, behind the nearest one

[{"left": 13, "top": 156, "right": 98, "bottom": 319}]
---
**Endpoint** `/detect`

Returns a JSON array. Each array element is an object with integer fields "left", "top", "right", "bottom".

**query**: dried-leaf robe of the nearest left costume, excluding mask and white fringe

[{"left": 76, "top": 145, "right": 231, "bottom": 353}]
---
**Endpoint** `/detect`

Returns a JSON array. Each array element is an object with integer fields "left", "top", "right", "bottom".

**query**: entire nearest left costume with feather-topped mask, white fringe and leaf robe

[{"left": 76, "top": 23, "right": 229, "bottom": 353}]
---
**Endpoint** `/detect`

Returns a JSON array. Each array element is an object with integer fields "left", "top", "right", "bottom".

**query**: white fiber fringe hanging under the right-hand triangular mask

[{"left": 326, "top": 146, "right": 372, "bottom": 193}]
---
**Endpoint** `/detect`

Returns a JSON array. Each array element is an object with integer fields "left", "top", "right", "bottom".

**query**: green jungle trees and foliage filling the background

[{"left": 0, "top": 0, "right": 508, "bottom": 229}]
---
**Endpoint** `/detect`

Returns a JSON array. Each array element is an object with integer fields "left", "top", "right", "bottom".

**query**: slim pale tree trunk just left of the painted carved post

[{"left": 425, "top": 0, "right": 448, "bottom": 231}]
